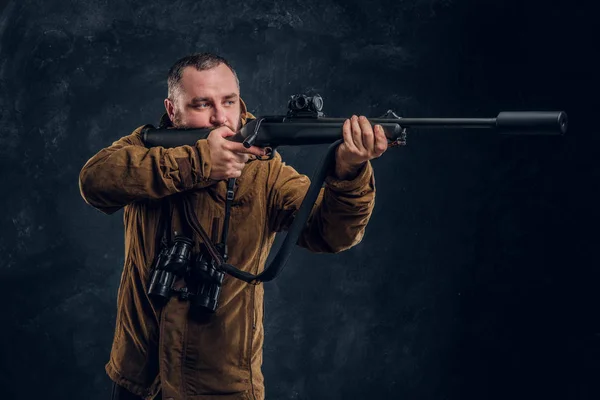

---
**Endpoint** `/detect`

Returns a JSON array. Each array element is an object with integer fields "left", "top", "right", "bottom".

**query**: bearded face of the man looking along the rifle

[{"left": 165, "top": 64, "right": 241, "bottom": 132}]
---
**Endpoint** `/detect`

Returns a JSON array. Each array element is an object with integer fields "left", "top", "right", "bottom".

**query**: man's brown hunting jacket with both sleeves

[{"left": 79, "top": 107, "right": 375, "bottom": 400}]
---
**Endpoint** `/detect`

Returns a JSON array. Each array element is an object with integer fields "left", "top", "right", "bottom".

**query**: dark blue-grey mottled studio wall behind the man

[{"left": 0, "top": 0, "right": 600, "bottom": 400}]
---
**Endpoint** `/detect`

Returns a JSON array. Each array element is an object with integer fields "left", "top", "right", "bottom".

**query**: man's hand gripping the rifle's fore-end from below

[{"left": 335, "top": 115, "right": 388, "bottom": 180}]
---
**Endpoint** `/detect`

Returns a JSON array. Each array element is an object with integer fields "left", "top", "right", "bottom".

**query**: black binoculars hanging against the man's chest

[{"left": 148, "top": 236, "right": 225, "bottom": 313}]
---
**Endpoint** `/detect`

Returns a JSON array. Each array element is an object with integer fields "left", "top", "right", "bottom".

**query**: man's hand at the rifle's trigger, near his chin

[{"left": 207, "top": 126, "right": 266, "bottom": 181}]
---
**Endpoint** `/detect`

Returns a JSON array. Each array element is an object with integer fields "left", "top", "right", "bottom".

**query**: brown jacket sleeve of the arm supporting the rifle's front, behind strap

[{"left": 268, "top": 153, "right": 375, "bottom": 253}]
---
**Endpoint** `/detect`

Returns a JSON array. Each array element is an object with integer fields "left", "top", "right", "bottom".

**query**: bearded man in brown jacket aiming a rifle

[{"left": 80, "top": 53, "right": 387, "bottom": 400}]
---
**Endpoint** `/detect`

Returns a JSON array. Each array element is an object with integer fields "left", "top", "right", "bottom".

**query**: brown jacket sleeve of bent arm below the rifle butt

[{"left": 79, "top": 126, "right": 214, "bottom": 214}]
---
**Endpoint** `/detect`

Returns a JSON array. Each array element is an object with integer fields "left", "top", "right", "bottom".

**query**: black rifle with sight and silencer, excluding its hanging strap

[{"left": 143, "top": 95, "right": 567, "bottom": 151}]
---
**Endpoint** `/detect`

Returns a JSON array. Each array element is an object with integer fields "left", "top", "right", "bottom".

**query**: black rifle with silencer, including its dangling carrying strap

[{"left": 142, "top": 94, "right": 567, "bottom": 283}]
